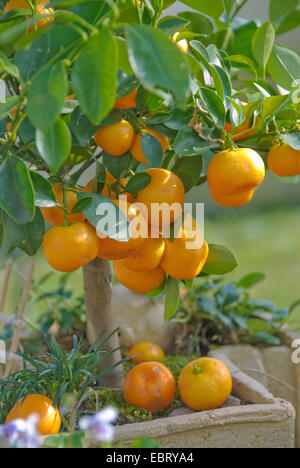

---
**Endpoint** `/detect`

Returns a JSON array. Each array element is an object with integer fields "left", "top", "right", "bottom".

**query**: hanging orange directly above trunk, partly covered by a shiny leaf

[{"left": 98, "top": 200, "right": 148, "bottom": 260}]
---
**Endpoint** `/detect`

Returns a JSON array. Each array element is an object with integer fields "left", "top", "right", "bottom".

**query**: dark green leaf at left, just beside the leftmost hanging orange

[{"left": 3, "top": 209, "right": 45, "bottom": 256}]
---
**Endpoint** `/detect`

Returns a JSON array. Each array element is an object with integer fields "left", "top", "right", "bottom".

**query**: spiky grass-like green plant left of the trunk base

[{"left": 0, "top": 332, "right": 121, "bottom": 423}]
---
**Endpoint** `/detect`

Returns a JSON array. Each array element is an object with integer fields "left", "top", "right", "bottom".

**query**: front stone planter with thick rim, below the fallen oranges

[{"left": 0, "top": 355, "right": 295, "bottom": 448}]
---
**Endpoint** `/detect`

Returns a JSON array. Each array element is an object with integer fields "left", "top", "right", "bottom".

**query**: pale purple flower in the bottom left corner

[{"left": 0, "top": 414, "right": 41, "bottom": 448}]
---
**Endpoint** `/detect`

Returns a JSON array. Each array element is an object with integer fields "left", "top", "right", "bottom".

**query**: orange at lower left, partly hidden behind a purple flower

[{"left": 5, "top": 395, "right": 61, "bottom": 435}]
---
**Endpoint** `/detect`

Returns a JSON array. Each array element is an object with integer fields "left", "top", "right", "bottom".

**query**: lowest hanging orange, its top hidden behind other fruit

[{"left": 114, "top": 260, "right": 166, "bottom": 294}]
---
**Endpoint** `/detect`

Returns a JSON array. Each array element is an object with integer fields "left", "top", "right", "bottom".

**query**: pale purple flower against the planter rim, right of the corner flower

[{"left": 79, "top": 406, "right": 118, "bottom": 442}]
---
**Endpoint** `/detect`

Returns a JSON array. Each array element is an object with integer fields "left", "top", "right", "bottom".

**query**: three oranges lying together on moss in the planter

[{"left": 123, "top": 342, "right": 232, "bottom": 413}]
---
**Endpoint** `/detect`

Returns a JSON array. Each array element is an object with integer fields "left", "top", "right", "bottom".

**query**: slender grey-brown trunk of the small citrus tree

[{"left": 83, "top": 258, "right": 123, "bottom": 389}]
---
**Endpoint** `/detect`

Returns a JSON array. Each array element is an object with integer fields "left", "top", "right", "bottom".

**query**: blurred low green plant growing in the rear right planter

[{"left": 174, "top": 273, "right": 300, "bottom": 355}]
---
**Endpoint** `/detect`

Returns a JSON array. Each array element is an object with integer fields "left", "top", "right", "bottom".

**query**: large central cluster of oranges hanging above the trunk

[{"left": 41, "top": 168, "right": 208, "bottom": 293}]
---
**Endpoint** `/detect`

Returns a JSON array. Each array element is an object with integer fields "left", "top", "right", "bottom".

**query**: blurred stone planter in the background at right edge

[{"left": 210, "top": 334, "right": 300, "bottom": 448}]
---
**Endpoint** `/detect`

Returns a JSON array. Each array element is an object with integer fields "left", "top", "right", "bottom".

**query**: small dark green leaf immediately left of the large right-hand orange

[{"left": 174, "top": 126, "right": 211, "bottom": 156}]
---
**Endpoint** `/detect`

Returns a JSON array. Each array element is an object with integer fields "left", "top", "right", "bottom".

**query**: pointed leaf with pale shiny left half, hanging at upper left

[{"left": 36, "top": 118, "right": 72, "bottom": 174}]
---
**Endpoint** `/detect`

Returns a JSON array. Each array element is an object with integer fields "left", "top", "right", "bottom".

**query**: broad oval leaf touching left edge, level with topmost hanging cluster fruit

[{"left": 0, "top": 156, "right": 35, "bottom": 224}]
